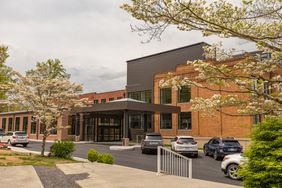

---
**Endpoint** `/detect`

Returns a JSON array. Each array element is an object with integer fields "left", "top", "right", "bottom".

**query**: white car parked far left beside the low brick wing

[{"left": 0, "top": 131, "right": 29, "bottom": 147}]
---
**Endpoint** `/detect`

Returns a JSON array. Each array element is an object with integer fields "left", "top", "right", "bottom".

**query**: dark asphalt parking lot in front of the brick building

[{"left": 25, "top": 142, "right": 241, "bottom": 185}]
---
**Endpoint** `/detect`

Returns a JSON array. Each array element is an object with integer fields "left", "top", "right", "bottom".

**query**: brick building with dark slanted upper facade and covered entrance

[{"left": 0, "top": 43, "right": 281, "bottom": 146}]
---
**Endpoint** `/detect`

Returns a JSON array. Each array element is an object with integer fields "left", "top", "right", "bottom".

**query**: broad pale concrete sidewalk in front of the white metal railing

[{"left": 57, "top": 163, "right": 242, "bottom": 188}]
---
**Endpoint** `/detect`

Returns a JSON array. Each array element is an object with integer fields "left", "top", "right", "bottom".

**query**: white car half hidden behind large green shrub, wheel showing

[{"left": 221, "top": 153, "right": 246, "bottom": 180}]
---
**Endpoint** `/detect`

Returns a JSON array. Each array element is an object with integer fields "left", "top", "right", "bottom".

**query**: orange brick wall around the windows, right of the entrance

[{"left": 154, "top": 58, "right": 252, "bottom": 141}]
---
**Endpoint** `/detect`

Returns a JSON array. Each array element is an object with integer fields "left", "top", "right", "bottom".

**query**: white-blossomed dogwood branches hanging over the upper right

[{"left": 122, "top": 0, "right": 282, "bottom": 116}]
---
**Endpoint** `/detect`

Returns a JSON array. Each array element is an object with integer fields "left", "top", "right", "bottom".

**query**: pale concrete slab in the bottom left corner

[{"left": 0, "top": 166, "right": 43, "bottom": 188}]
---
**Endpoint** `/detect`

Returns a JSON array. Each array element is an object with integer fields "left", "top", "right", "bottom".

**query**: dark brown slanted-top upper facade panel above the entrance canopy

[{"left": 126, "top": 42, "right": 208, "bottom": 92}]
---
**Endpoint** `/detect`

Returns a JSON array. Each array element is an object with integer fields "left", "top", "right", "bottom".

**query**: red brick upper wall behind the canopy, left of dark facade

[{"left": 80, "top": 89, "right": 125, "bottom": 103}]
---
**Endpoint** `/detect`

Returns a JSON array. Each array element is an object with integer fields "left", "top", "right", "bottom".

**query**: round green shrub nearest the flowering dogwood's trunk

[{"left": 50, "top": 141, "right": 75, "bottom": 159}]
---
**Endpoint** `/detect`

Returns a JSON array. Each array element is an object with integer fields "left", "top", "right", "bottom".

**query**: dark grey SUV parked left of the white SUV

[{"left": 141, "top": 133, "right": 164, "bottom": 153}]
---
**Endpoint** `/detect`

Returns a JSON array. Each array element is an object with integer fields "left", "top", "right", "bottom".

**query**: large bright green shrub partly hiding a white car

[{"left": 238, "top": 117, "right": 282, "bottom": 188}]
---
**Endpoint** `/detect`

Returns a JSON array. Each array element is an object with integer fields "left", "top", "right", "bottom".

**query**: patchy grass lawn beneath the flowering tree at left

[{"left": 0, "top": 150, "right": 76, "bottom": 167}]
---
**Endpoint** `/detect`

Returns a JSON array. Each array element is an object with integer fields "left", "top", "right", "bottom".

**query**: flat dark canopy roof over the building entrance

[{"left": 71, "top": 98, "right": 180, "bottom": 113}]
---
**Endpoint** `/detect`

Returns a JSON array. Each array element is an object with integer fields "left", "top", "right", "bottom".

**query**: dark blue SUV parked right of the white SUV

[{"left": 204, "top": 137, "right": 242, "bottom": 160}]
